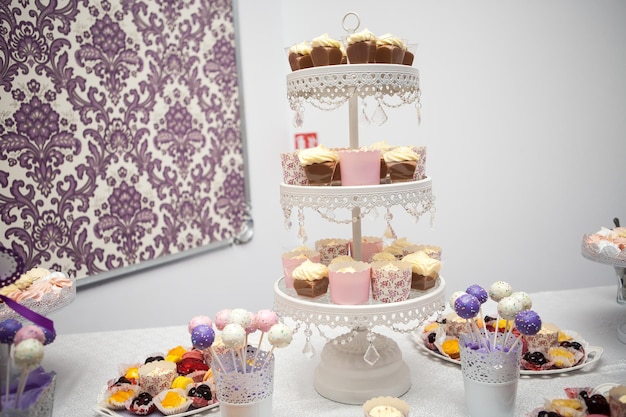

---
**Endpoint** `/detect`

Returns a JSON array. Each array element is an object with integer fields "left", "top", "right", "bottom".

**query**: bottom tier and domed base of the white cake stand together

[{"left": 274, "top": 277, "right": 445, "bottom": 404}]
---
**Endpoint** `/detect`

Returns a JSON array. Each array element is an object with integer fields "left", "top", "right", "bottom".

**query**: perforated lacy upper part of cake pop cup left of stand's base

[{"left": 214, "top": 350, "right": 274, "bottom": 404}]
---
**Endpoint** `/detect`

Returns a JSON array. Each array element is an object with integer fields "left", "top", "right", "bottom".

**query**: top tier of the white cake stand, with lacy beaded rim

[{"left": 287, "top": 64, "right": 420, "bottom": 111}]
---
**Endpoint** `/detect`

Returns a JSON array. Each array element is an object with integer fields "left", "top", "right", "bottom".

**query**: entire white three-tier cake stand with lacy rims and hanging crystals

[{"left": 274, "top": 13, "right": 445, "bottom": 404}]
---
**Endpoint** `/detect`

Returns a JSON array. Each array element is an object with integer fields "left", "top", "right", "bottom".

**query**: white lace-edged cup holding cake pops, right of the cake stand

[{"left": 459, "top": 333, "right": 522, "bottom": 417}]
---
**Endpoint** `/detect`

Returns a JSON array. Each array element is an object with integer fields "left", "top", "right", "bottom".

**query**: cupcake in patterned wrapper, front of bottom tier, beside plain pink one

[{"left": 371, "top": 260, "right": 412, "bottom": 303}]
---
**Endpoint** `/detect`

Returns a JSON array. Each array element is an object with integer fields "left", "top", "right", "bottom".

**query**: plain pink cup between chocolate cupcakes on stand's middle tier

[{"left": 338, "top": 149, "right": 380, "bottom": 186}]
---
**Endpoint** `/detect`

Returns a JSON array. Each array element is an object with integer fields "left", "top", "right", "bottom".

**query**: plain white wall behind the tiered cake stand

[{"left": 52, "top": 0, "right": 626, "bottom": 333}]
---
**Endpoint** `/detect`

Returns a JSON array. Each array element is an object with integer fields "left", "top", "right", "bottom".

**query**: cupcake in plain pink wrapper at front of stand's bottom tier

[{"left": 328, "top": 261, "right": 371, "bottom": 305}]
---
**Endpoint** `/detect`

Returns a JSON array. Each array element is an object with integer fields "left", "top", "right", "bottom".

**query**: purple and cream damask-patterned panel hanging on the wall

[{"left": 0, "top": 0, "right": 248, "bottom": 282}]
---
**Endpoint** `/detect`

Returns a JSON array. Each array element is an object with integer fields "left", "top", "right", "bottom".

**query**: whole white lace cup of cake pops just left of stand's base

[{"left": 214, "top": 350, "right": 274, "bottom": 417}]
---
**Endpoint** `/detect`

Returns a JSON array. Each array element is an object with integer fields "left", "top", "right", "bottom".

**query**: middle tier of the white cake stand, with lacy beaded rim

[{"left": 280, "top": 177, "right": 435, "bottom": 226}]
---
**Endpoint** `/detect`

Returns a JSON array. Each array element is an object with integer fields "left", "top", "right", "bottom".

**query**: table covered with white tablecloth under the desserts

[{"left": 43, "top": 286, "right": 626, "bottom": 417}]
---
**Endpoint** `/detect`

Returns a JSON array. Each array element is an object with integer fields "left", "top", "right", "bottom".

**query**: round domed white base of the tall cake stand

[{"left": 315, "top": 329, "right": 411, "bottom": 404}]
